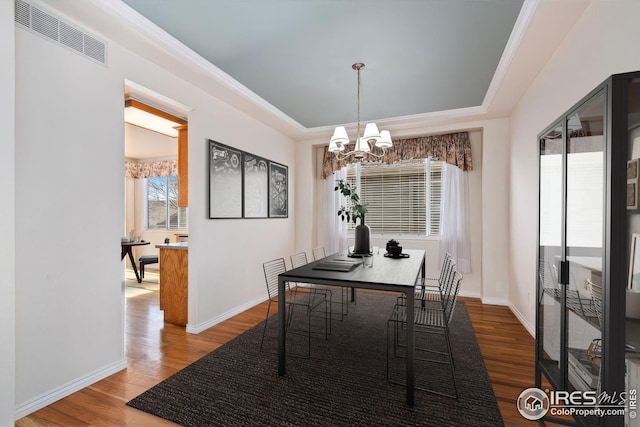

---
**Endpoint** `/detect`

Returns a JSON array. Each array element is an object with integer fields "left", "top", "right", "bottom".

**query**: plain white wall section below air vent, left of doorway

[{"left": 15, "top": 23, "right": 125, "bottom": 412}]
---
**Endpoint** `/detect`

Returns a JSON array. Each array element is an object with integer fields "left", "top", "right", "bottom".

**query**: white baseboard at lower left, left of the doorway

[{"left": 14, "top": 358, "right": 127, "bottom": 420}]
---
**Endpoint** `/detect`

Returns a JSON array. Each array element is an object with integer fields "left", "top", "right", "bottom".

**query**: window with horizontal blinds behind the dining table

[{"left": 347, "top": 159, "right": 443, "bottom": 236}]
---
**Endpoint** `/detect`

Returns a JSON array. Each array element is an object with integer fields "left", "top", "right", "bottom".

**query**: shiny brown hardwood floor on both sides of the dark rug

[{"left": 16, "top": 291, "right": 537, "bottom": 427}]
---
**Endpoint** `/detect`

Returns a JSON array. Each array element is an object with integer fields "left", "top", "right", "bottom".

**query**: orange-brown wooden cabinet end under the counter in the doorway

[{"left": 158, "top": 244, "right": 189, "bottom": 326}]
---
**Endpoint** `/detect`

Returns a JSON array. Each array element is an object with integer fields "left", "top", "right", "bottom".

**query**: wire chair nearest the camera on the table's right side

[{"left": 387, "top": 271, "right": 462, "bottom": 399}]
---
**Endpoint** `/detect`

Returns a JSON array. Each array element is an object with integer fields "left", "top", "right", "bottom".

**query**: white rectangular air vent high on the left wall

[{"left": 15, "top": 0, "right": 107, "bottom": 65}]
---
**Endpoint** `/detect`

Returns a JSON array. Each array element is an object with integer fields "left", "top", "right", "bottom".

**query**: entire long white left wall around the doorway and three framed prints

[{"left": 15, "top": 3, "right": 296, "bottom": 416}]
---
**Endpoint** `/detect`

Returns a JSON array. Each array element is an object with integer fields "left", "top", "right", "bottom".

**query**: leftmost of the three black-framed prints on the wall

[{"left": 209, "top": 139, "right": 243, "bottom": 219}]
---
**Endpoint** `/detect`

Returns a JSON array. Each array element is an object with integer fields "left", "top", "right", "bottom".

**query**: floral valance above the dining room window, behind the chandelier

[{"left": 322, "top": 132, "right": 473, "bottom": 179}]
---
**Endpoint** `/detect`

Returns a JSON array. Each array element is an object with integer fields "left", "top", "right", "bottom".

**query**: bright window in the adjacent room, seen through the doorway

[{"left": 146, "top": 176, "right": 187, "bottom": 230}]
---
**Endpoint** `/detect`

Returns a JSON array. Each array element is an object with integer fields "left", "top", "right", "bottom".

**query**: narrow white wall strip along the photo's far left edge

[{"left": 0, "top": 1, "right": 16, "bottom": 427}]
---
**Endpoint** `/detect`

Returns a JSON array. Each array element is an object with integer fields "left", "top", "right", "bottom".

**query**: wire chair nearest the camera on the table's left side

[{"left": 260, "top": 258, "right": 329, "bottom": 358}]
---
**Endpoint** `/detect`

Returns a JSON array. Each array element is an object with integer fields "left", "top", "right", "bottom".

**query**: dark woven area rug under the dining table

[{"left": 127, "top": 291, "right": 503, "bottom": 426}]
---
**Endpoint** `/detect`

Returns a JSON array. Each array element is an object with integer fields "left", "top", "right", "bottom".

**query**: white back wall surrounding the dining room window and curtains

[{"left": 296, "top": 119, "right": 509, "bottom": 305}]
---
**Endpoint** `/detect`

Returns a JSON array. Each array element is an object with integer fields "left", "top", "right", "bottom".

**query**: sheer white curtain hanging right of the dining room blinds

[{"left": 440, "top": 164, "right": 471, "bottom": 273}]
